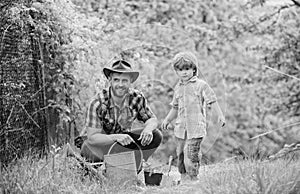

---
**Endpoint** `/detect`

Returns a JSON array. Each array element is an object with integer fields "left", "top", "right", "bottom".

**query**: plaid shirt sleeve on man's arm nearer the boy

[{"left": 136, "top": 93, "right": 156, "bottom": 123}]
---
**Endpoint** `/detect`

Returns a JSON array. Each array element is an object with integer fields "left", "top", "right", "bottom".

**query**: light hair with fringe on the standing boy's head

[{"left": 173, "top": 51, "right": 198, "bottom": 76}]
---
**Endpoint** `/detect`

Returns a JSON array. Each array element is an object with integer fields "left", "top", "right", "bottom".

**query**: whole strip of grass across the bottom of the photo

[{"left": 0, "top": 152, "right": 300, "bottom": 194}]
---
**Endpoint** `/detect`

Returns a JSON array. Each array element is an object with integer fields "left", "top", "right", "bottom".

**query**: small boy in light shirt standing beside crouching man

[{"left": 162, "top": 52, "right": 225, "bottom": 182}]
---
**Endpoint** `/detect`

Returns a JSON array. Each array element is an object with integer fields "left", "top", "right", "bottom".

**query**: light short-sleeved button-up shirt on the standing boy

[{"left": 171, "top": 76, "right": 217, "bottom": 139}]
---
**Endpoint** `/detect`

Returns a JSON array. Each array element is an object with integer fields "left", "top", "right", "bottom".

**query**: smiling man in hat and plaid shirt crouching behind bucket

[{"left": 81, "top": 60, "right": 162, "bottom": 168}]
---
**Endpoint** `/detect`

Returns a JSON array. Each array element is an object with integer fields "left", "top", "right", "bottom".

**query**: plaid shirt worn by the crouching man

[{"left": 86, "top": 88, "right": 155, "bottom": 134}]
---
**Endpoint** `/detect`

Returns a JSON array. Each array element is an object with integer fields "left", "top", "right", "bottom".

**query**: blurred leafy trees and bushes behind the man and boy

[{"left": 2, "top": 0, "right": 300, "bottom": 163}]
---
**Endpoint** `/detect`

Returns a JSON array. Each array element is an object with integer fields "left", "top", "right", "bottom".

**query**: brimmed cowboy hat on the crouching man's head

[{"left": 103, "top": 60, "right": 139, "bottom": 83}]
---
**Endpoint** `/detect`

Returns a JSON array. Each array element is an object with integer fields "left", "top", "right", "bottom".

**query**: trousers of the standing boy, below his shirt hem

[{"left": 176, "top": 137, "right": 203, "bottom": 177}]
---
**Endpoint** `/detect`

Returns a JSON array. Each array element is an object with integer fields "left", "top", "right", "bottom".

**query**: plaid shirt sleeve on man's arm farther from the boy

[{"left": 85, "top": 99, "right": 101, "bottom": 129}]
